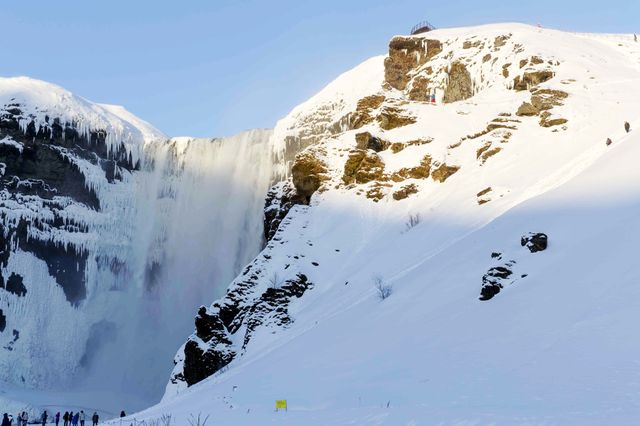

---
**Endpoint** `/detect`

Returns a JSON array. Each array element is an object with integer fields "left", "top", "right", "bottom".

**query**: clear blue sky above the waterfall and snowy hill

[{"left": 0, "top": 0, "right": 640, "bottom": 136}]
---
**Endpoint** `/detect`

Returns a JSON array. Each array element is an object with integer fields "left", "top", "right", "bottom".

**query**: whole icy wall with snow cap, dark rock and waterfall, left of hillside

[{"left": 0, "top": 78, "right": 273, "bottom": 401}]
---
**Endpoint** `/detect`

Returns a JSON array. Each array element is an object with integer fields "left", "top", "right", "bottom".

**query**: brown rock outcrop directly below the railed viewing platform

[{"left": 384, "top": 36, "right": 442, "bottom": 90}]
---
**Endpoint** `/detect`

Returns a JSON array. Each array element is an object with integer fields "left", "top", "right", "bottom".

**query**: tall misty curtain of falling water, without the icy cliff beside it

[{"left": 77, "top": 130, "right": 273, "bottom": 404}]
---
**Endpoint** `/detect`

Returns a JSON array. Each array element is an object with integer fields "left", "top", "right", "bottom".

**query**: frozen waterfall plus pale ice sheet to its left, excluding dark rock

[{"left": 0, "top": 130, "right": 275, "bottom": 409}]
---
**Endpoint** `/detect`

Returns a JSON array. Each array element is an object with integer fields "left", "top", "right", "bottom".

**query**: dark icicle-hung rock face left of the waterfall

[{"left": 0, "top": 103, "right": 139, "bottom": 305}]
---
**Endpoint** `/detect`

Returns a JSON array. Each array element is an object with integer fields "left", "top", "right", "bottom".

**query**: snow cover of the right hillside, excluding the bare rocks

[{"left": 131, "top": 24, "right": 640, "bottom": 426}]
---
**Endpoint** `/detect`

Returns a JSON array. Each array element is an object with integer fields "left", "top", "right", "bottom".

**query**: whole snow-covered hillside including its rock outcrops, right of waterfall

[{"left": 152, "top": 24, "right": 640, "bottom": 425}]
